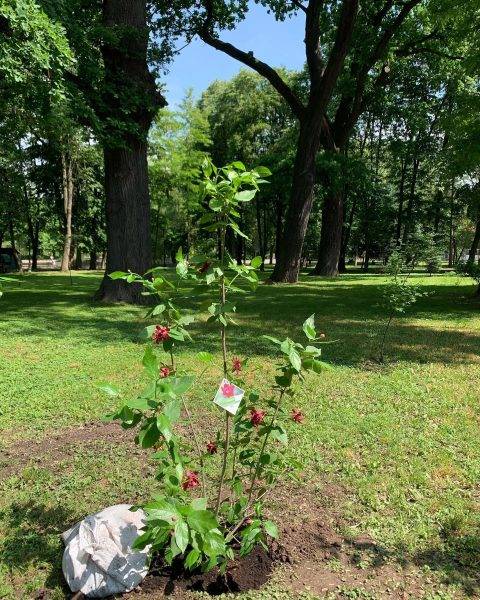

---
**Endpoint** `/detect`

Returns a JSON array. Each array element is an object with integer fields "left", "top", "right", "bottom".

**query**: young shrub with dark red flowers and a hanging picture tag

[{"left": 103, "top": 161, "right": 326, "bottom": 570}]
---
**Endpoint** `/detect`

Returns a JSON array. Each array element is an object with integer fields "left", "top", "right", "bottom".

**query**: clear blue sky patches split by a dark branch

[{"left": 163, "top": 5, "right": 305, "bottom": 108}]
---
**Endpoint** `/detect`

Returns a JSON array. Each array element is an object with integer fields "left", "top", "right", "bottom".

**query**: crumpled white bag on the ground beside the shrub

[{"left": 62, "top": 504, "right": 148, "bottom": 598}]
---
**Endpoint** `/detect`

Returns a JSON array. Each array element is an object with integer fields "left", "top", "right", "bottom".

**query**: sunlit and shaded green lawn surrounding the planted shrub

[{"left": 0, "top": 273, "right": 480, "bottom": 600}]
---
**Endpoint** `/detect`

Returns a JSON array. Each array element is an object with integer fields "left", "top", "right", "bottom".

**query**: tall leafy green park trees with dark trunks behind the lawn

[{"left": 0, "top": 0, "right": 480, "bottom": 301}]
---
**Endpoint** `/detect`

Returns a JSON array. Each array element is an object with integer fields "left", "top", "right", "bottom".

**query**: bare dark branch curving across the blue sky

[{"left": 199, "top": 0, "right": 305, "bottom": 121}]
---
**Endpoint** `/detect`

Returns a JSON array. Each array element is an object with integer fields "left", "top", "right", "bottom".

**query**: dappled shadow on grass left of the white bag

[{"left": 0, "top": 502, "right": 74, "bottom": 592}]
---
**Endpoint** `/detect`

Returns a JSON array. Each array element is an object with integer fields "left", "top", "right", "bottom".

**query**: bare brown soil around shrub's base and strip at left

[{"left": 0, "top": 423, "right": 470, "bottom": 600}]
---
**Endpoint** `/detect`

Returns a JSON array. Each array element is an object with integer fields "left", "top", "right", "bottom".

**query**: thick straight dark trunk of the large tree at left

[{"left": 97, "top": 0, "right": 165, "bottom": 303}]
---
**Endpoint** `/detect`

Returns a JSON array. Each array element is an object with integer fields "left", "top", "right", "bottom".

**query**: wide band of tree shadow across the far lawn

[{"left": 2, "top": 275, "right": 480, "bottom": 366}]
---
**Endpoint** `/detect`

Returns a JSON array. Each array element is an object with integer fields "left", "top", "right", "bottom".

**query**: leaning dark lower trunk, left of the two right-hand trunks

[{"left": 271, "top": 119, "right": 320, "bottom": 283}]
